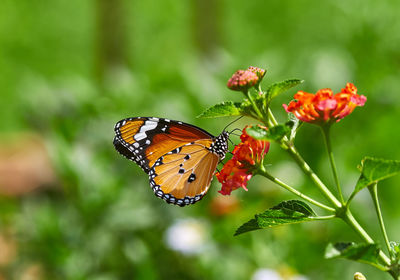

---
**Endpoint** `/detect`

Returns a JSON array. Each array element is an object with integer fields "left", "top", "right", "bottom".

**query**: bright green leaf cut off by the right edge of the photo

[{"left": 349, "top": 157, "right": 400, "bottom": 200}]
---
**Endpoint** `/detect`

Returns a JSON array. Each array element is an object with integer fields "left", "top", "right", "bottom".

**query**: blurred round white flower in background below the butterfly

[{"left": 165, "top": 219, "right": 209, "bottom": 255}]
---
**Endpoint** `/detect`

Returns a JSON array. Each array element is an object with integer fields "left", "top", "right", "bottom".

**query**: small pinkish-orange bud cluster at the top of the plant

[{"left": 227, "top": 66, "right": 265, "bottom": 91}]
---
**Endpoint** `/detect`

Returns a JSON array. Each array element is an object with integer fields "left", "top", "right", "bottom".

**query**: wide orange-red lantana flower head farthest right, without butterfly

[{"left": 283, "top": 83, "right": 367, "bottom": 124}]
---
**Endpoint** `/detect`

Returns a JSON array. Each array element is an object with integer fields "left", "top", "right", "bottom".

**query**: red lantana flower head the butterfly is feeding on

[{"left": 216, "top": 126, "right": 269, "bottom": 195}]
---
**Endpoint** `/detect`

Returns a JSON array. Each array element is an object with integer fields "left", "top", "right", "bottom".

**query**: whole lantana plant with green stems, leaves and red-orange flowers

[{"left": 199, "top": 67, "right": 400, "bottom": 279}]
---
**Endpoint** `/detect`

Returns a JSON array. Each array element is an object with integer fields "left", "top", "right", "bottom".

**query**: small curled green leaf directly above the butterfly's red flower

[{"left": 246, "top": 121, "right": 293, "bottom": 142}]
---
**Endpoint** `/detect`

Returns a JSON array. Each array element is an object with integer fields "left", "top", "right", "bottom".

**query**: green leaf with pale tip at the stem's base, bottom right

[{"left": 325, "top": 242, "right": 385, "bottom": 270}]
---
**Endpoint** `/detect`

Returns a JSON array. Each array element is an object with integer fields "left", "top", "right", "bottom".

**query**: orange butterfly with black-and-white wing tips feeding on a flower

[{"left": 113, "top": 117, "right": 229, "bottom": 207}]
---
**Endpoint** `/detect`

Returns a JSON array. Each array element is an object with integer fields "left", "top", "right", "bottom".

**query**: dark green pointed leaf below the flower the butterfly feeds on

[{"left": 235, "top": 200, "right": 316, "bottom": 235}]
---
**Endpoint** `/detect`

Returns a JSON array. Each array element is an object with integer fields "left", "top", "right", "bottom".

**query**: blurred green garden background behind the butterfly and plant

[{"left": 0, "top": 0, "right": 400, "bottom": 280}]
